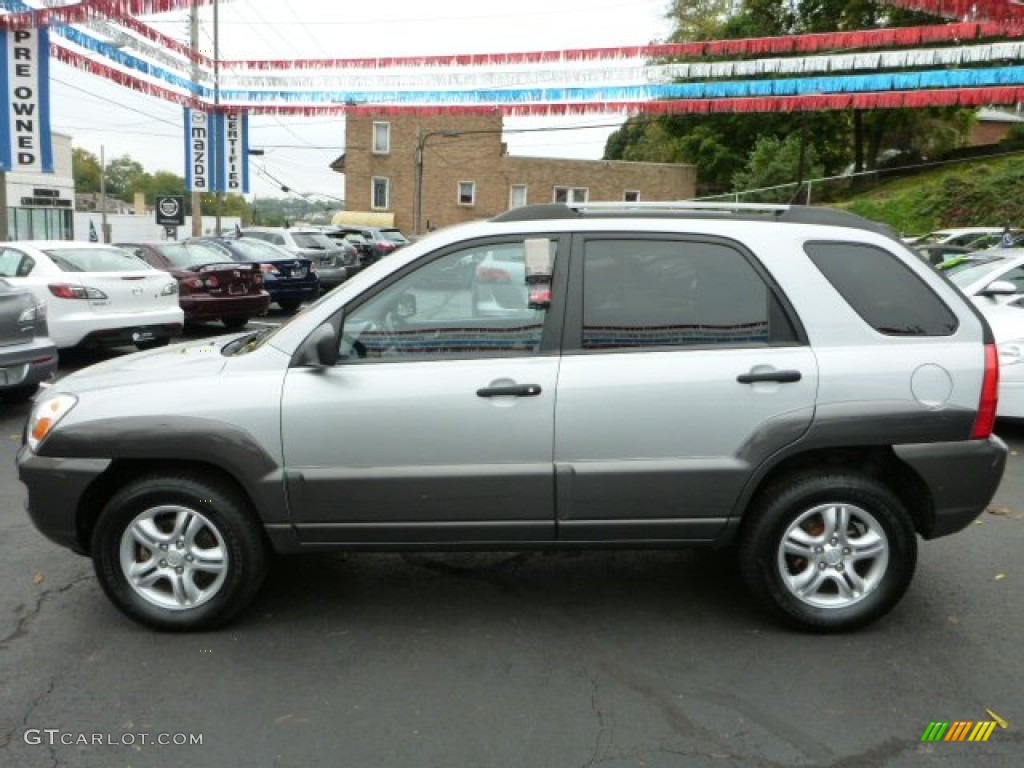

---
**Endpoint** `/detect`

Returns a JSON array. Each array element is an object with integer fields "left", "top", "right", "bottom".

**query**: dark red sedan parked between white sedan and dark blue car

[{"left": 117, "top": 241, "right": 270, "bottom": 331}]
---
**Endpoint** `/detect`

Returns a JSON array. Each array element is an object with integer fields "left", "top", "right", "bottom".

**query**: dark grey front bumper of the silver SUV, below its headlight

[{"left": 17, "top": 445, "right": 111, "bottom": 555}]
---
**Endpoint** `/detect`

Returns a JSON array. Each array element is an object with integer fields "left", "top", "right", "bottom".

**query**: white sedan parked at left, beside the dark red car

[{"left": 0, "top": 241, "right": 184, "bottom": 349}]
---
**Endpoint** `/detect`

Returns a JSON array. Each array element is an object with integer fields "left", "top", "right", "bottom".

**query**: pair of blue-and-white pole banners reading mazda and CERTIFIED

[{"left": 185, "top": 109, "right": 249, "bottom": 195}]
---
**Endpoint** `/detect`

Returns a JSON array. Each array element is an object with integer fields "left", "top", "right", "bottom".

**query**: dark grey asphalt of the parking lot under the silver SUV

[{"left": 0, "top": 315, "right": 1024, "bottom": 768}]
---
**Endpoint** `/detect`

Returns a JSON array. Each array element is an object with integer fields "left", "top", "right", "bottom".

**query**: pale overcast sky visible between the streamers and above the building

[{"left": 46, "top": 0, "right": 671, "bottom": 199}]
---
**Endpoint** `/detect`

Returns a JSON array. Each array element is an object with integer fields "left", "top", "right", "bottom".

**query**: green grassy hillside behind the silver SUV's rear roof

[{"left": 835, "top": 153, "right": 1024, "bottom": 233}]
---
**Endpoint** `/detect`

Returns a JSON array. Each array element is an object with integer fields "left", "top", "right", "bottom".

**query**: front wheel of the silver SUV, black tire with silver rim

[{"left": 92, "top": 472, "right": 267, "bottom": 632}]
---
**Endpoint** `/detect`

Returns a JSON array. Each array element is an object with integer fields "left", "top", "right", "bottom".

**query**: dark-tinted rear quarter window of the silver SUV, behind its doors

[{"left": 805, "top": 243, "right": 956, "bottom": 336}]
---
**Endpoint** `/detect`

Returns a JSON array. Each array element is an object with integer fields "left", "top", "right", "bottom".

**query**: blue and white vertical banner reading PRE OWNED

[{"left": 0, "top": 27, "right": 53, "bottom": 173}]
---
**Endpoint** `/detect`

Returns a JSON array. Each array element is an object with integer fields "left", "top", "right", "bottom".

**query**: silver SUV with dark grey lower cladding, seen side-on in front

[{"left": 18, "top": 204, "right": 1007, "bottom": 631}]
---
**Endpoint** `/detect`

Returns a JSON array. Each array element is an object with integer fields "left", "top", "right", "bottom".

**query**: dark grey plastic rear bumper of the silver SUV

[{"left": 894, "top": 435, "right": 1009, "bottom": 539}]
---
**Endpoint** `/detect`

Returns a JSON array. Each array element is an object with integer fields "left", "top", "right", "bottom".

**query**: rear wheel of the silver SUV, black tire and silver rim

[{"left": 737, "top": 472, "right": 918, "bottom": 632}]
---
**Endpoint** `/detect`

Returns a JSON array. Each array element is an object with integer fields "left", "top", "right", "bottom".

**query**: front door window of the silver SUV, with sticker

[{"left": 340, "top": 239, "right": 557, "bottom": 362}]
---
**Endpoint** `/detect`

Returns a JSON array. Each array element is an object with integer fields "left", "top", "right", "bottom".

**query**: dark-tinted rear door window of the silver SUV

[{"left": 583, "top": 240, "right": 796, "bottom": 349}]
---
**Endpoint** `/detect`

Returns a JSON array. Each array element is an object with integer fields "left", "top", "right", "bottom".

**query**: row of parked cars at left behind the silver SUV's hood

[{"left": 0, "top": 227, "right": 408, "bottom": 400}]
